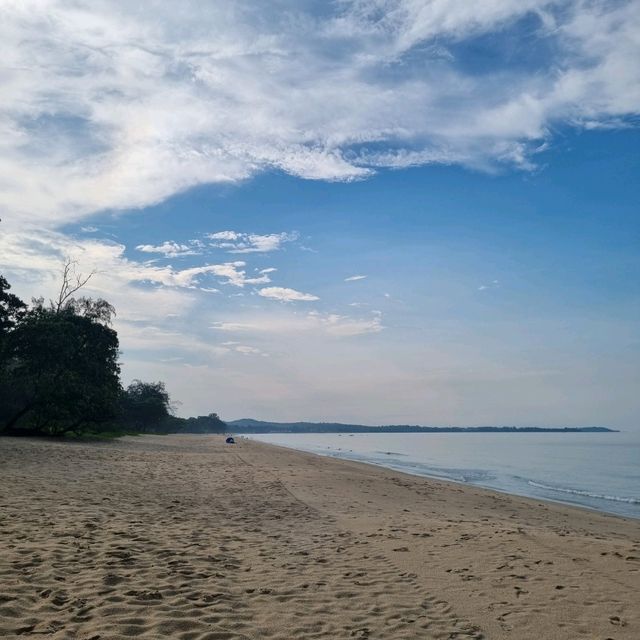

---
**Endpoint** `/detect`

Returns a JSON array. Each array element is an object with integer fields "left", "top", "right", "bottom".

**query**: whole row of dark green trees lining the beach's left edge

[{"left": 0, "top": 268, "right": 226, "bottom": 436}]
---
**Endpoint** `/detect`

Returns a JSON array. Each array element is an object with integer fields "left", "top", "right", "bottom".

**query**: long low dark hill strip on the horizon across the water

[{"left": 227, "top": 418, "right": 617, "bottom": 433}]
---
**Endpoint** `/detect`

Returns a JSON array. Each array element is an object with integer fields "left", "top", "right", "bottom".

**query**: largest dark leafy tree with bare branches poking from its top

[{"left": 0, "top": 260, "right": 121, "bottom": 435}]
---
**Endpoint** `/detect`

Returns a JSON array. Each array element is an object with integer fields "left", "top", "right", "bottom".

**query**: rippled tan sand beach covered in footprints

[{"left": 0, "top": 436, "right": 640, "bottom": 640}]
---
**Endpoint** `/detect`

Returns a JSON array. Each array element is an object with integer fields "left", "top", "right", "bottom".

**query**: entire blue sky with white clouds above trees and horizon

[{"left": 0, "top": 0, "right": 640, "bottom": 429}]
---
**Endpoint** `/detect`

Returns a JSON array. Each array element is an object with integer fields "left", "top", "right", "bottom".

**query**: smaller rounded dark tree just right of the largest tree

[{"left": 120, "top": 380, "right": 172, "bottom": 431}]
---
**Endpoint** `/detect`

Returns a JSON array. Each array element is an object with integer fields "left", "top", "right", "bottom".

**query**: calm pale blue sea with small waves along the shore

[{"left": 248, "top": 432, "right": 640, "bottom": 518}]
